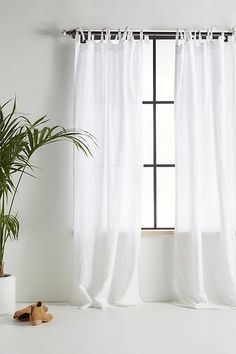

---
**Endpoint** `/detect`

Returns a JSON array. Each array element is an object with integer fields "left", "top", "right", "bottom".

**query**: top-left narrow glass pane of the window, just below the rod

[{"left": 143, "top": 41, "right": 153, "bottom": 101}]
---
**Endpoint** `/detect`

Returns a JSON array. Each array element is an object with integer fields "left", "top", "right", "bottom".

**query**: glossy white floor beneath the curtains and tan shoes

[{"left": 0, "top": 303, "right": 236, "bottom": 354}]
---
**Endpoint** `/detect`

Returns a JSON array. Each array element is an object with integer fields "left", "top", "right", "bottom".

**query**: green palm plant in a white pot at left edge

[{"left": 0, "top": 100, "right": 94, "bottom": 314}]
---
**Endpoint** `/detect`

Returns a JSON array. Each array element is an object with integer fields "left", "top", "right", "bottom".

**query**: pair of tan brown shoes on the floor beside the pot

[{"left": 13, "top": 301, "right": 53, "bottom": 326}]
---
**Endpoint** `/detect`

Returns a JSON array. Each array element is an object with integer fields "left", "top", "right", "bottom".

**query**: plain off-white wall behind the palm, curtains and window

[{"left": 0, "top": 0, "right": 236, "bottom": 301}]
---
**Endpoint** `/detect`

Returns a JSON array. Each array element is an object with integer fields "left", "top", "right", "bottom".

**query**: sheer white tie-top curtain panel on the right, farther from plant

[{"left": 173, "top": 32, "right": 236, "bottom": 308}]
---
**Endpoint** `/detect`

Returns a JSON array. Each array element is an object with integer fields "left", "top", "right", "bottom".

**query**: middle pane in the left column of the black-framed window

[{"left": 143, "top": 104, "right": 153, "bottom": 164}]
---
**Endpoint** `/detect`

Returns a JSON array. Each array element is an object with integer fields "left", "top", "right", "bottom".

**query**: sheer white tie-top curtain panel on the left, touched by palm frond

[{"left": 73, "top": 33, "right": 143, "bottom": 308}]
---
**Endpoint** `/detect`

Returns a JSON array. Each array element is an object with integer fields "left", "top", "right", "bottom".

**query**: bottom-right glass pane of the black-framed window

[{"left": 157, "top": 167, "right": 175, "bottom": 227}]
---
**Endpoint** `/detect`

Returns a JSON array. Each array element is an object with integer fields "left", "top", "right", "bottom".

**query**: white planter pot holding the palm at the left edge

[{"left": 0, "top": 274, "right": 16, "bottom": 315}]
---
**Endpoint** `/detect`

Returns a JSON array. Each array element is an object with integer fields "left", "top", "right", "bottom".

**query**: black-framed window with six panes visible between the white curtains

[{"left": 142, "top": 38, "right": 175, "bottom": 230}]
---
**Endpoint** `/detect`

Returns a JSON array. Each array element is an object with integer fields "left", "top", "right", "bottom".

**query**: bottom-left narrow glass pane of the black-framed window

[{"left": 142, "top": 167, "right": 154, "bottom": 227}]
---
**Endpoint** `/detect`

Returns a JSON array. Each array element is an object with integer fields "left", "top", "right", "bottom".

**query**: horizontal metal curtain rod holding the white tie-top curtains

[{"left": 62, "top": 27, "right": 235, "bottom": 39}]
